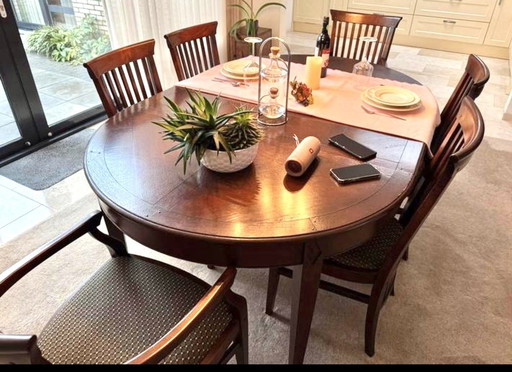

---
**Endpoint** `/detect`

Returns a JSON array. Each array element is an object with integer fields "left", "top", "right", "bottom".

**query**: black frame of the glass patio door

[{"left": 0, "top": 0, "right": 106, "bottom": 166}]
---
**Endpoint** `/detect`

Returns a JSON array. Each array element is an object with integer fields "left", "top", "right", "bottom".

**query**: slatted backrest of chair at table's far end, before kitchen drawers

[{"left": 331, "top": 9, "right": 402, "bottom": 65}]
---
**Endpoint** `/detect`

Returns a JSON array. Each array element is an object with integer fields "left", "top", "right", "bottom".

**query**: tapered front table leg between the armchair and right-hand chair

[{"left": 289, "top": 243, "right": 323, "bottom": 364}]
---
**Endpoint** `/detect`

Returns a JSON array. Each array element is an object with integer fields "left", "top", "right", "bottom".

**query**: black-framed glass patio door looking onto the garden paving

[{"left": 0, "top": 0, "right": 110, "bottom": 165}]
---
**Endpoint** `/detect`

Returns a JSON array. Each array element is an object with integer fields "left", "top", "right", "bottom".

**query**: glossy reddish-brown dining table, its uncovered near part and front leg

[{"left": 84, "top": 58, "right": 426, "bottom": 363}]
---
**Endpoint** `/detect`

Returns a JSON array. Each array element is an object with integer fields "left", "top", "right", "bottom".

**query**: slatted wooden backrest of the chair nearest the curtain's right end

[{"left": 164, "top": 21, "right": 220, "bottom": 81}]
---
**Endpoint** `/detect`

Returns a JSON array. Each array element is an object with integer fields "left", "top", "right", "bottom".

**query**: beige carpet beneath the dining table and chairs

[{"left": 0, "top": 139, "right": 512, "bottom": 364}]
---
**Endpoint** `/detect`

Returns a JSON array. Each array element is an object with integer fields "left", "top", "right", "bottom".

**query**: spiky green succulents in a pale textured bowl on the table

[{"left": 153, "top": 90, "right": 263, "bottom": 173}]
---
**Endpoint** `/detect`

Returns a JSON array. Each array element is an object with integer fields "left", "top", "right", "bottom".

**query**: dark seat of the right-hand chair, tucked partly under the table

[{"left": 327, "top": 218, "right": 403, "bottom": 270}]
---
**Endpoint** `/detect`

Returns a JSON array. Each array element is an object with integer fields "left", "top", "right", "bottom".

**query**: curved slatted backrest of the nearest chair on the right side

[{"left": 381, "top": 97, "right": 485, "bottom": 284}]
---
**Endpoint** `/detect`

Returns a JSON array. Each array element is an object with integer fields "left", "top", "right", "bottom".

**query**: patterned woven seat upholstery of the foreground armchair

[{"left": 38, "top": 257, "right": 232, "bottom": 364}]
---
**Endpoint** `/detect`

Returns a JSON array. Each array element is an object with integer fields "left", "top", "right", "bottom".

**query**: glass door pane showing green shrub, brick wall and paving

[{"left": 12, "top": 0, "right": 111, "bottom": 127}]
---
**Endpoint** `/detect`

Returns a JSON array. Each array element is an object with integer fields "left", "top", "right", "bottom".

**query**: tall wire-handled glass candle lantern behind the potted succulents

[{"left": 258, "top": 37, "right": 291, "bottom": 125}]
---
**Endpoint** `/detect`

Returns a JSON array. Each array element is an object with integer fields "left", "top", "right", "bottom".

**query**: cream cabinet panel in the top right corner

[{"left": 484, "top": 0, "right": 512, "bottom": 48}]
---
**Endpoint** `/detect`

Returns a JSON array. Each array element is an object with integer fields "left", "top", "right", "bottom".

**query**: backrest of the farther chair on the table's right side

[{"left": 430, "top": 54, "right": 490, "bottom": 154}]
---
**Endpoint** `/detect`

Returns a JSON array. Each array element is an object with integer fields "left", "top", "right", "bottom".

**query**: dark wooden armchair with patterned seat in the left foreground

[{"left": 0, "top": 212, "right": 248, "bottom": 364}]
